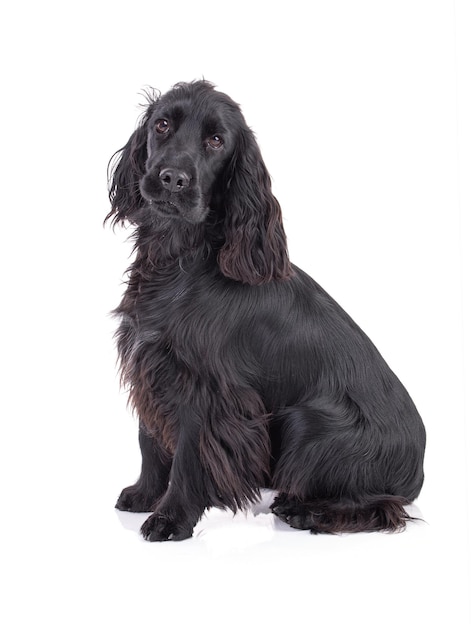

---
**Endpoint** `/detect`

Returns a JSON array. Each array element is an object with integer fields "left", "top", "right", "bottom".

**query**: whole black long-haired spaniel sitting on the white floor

[{"left": 105, "top": 81, "right": 426, "bottom": 541}]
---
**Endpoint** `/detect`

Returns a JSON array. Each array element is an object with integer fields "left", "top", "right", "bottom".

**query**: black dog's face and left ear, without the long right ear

[{"left": 109, "top": 81, "right": 243, "bottom": 223}]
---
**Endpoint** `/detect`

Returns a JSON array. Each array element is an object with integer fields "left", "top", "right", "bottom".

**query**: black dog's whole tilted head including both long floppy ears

[{"left": 107, "top": 81, "right": 290, "bottom": 284}]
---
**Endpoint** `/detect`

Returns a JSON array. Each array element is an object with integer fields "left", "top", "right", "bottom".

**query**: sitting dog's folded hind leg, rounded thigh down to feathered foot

[{"left": 271, "top": 398, "right": 423, "bottom": 533}]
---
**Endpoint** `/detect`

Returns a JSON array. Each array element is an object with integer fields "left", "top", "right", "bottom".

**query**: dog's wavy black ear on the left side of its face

[{"left": 105, "top": 107, "right": 151, "bottom": 225}]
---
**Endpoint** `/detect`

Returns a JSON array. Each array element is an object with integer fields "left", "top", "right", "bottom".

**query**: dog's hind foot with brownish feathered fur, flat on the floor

[{"left": 271, "top": 494, "right": 418, "bottom": 534}]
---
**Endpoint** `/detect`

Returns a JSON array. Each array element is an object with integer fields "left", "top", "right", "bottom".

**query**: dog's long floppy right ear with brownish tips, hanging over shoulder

[{"left": 218, "top": 128, "right": 292, "bottom": 285}]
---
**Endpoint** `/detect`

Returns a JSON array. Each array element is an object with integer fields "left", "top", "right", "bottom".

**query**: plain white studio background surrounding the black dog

[{"left": 0, "top": 0, "right": 472, "bottom": 626}]
